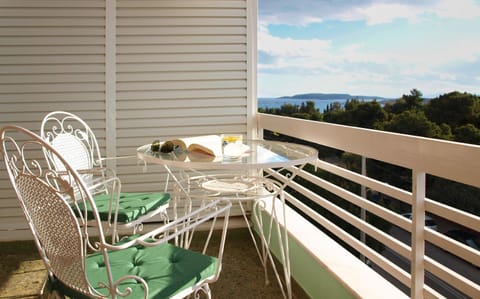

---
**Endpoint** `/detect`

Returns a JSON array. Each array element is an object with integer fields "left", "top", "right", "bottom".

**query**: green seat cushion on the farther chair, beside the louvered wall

[{"left": 80, "top": 192, "right": 170, "bottom": 223}]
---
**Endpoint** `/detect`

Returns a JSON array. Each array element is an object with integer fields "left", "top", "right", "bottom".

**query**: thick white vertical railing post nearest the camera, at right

[{"left": 410, "top": 170, "right": 426, "bottom": 299}]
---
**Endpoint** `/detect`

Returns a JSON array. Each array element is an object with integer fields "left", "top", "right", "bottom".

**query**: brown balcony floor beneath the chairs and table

[{"left": 0, "top": 229, "right": 309, "bottom": 299}]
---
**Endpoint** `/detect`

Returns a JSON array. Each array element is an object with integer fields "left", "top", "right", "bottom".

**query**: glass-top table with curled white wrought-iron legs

[{"left": 137, "top": 140, "right": 318, "bottom": 298}]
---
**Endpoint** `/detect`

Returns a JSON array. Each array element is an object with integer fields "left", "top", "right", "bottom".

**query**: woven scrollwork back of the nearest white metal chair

[{"left": 0, "top": 126, "right": 108, "bottom": 293}]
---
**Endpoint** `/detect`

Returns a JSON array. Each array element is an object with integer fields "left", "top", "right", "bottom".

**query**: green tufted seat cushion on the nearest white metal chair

[{"left": 53, "top": 244, "right": 218, "bottom": 299}]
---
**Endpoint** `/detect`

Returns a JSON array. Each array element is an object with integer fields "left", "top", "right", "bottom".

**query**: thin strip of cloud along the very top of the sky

[{"left": 259, "top": 0, "right": 480, "bottom": 25}]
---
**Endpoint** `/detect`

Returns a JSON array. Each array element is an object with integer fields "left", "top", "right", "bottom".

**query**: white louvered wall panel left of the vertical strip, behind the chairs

[{"left": 0, "top": 0, "right": 105, "bottom": 240}]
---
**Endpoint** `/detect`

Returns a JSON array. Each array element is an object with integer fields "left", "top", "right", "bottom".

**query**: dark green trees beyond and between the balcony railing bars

[{"left": 259, "top": 89, "right": 480, "bottom": 255}]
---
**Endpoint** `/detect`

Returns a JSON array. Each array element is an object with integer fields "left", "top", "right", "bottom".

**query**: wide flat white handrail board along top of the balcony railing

[{"left": 257, "top": 113, "right": 480, "bottom": 187}]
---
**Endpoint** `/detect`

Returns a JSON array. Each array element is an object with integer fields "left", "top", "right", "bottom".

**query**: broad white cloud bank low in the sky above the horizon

[{"left": 258, "top": 22, "right": 480, "bottom": 97}]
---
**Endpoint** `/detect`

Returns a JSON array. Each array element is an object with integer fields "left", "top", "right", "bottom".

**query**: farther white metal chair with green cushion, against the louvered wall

[{"left": 40, "top": 111, "right": 170, "bottom": 241}]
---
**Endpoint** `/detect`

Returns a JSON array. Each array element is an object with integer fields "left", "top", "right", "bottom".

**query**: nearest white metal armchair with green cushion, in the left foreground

[{"left": 0, "top": 126, "right": 231, "bottom": 298}]
